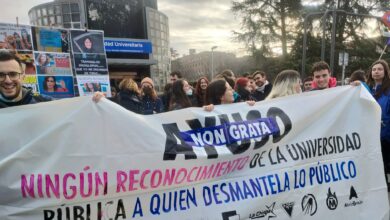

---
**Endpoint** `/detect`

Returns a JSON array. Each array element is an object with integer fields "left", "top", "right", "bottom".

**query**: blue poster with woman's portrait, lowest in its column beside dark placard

[{"left": 38, "top": 75, "right": 74, "bottom": 98}]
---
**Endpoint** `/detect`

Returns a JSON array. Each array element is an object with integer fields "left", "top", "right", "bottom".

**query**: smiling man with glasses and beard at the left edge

[{"left": 0, "top": 50, "right": 54, "bottom": 108}]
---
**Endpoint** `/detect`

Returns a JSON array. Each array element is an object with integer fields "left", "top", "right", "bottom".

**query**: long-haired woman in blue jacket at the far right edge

[{"left": 367, "top": 60, "right": 390, "bottom": 185}]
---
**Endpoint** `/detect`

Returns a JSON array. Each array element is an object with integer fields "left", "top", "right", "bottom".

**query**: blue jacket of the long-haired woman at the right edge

[{"left": 371, "top": 86, "right": 390, "bottom": 142}]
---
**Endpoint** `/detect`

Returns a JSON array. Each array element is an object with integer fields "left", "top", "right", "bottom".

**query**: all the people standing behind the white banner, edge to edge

[{"left": 0, "top": 50, "right": 390, "bottom": 188}]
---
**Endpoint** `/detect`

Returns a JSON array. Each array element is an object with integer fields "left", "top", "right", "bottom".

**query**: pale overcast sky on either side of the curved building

[{"left": 0, "top": 0, "right": 244, "bottom": 55}]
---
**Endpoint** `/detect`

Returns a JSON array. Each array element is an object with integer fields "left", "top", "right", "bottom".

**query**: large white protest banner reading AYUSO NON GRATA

[{"left": 0, "top": 86, "right": 389, "bottom": 220}]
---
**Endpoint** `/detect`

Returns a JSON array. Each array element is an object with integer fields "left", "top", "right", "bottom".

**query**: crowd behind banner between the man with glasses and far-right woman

[{"left": 106, "top": 61, "right": 354, "bottom": 115}]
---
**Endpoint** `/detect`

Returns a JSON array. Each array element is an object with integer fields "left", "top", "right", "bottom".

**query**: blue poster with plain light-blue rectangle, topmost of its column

[{"left": 32, "top": 27, "right": 69, "bottom": 53}]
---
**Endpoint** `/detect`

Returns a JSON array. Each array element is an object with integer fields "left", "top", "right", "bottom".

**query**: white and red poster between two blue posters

[{"left": 34, "top": 52, "right": 72, "bottom": 76}]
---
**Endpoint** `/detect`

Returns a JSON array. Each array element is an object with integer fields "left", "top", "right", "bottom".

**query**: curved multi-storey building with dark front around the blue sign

[{"left": 29, "top": 0, "right": 171, "bottom": 90}]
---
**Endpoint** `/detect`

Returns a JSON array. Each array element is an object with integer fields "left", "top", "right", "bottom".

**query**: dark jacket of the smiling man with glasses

[{"left": 0, "top": 87, "right": 55, "bottom": 108}]
